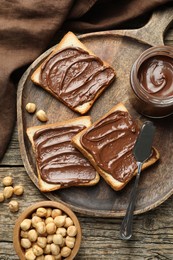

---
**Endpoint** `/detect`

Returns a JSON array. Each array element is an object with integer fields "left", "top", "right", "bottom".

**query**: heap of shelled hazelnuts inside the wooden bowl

[{"left": 20, "top": 207, "right": 77, "bottom": 260}]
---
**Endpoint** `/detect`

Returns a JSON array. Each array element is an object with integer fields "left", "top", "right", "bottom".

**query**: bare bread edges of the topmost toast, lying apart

[{"left": 31, "top": 32, "right": 116, "bottom": 115}]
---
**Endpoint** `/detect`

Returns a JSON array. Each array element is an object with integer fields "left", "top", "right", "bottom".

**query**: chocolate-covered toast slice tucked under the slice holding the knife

[{"left": 27, "top": 116, "right": 100, "bottom": 192}]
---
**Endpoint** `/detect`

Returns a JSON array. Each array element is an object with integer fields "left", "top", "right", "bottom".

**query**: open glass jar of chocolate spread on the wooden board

[{"left": 130, "top": 46, "right": 173, "bottom": 118}]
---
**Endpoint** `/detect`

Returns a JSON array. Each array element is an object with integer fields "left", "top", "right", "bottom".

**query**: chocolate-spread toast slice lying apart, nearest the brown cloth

[{"left": 31, "top": 32, "right": 115, "bottom": 114}]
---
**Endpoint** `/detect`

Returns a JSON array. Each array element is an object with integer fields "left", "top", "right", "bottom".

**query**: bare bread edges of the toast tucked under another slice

[{"left": 26, "top": 116, "right": 100, "bottom": 192}]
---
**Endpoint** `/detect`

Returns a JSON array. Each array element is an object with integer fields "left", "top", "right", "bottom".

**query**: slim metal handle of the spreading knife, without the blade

[{"left": 120, "top": 162, "right": 142, "bottom": 240}]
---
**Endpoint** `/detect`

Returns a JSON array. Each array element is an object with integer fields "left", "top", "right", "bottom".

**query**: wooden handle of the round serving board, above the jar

[{"left": 125, "top": 7, "right": 173, "bottom": 46}]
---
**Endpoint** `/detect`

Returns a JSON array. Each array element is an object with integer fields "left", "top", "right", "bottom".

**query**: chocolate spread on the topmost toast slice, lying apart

[{"left": 40, "top": 47, "right": 115, "bottom": 108}]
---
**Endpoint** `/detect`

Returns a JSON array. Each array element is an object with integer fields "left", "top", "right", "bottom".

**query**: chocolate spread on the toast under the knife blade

[{"left": 80, "top": 111, "right": 139, "bottom": 182}]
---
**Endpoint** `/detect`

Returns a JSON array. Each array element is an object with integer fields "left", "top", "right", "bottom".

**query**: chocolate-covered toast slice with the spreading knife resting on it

[{"left": 72, "top": 103, "right": 159, "bottom": 191}]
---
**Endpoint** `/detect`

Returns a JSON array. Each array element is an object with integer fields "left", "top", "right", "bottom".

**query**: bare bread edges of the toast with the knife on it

[{"left": 72, "top": 103, "right": 160, "bottom": 191}]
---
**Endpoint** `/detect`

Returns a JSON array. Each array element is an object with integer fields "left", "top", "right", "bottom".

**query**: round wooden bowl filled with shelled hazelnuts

[{"left": 13, "top": 201, "right": 82, "bottom": 260}]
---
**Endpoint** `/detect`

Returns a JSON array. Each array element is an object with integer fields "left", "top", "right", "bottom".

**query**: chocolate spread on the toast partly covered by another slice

[{"left": 33, "top": 125, "right": 96, "bottom": 186}]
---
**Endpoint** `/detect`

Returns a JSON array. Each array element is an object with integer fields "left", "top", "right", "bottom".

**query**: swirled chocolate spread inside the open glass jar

[{"left": 138, "top": 55, "right": 173, "bottom": 98}]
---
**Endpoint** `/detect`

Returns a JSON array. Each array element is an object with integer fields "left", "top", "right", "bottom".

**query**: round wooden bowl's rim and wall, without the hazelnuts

[{"left": 13, "top": 201, "right": 82, "bottom": 260}]
